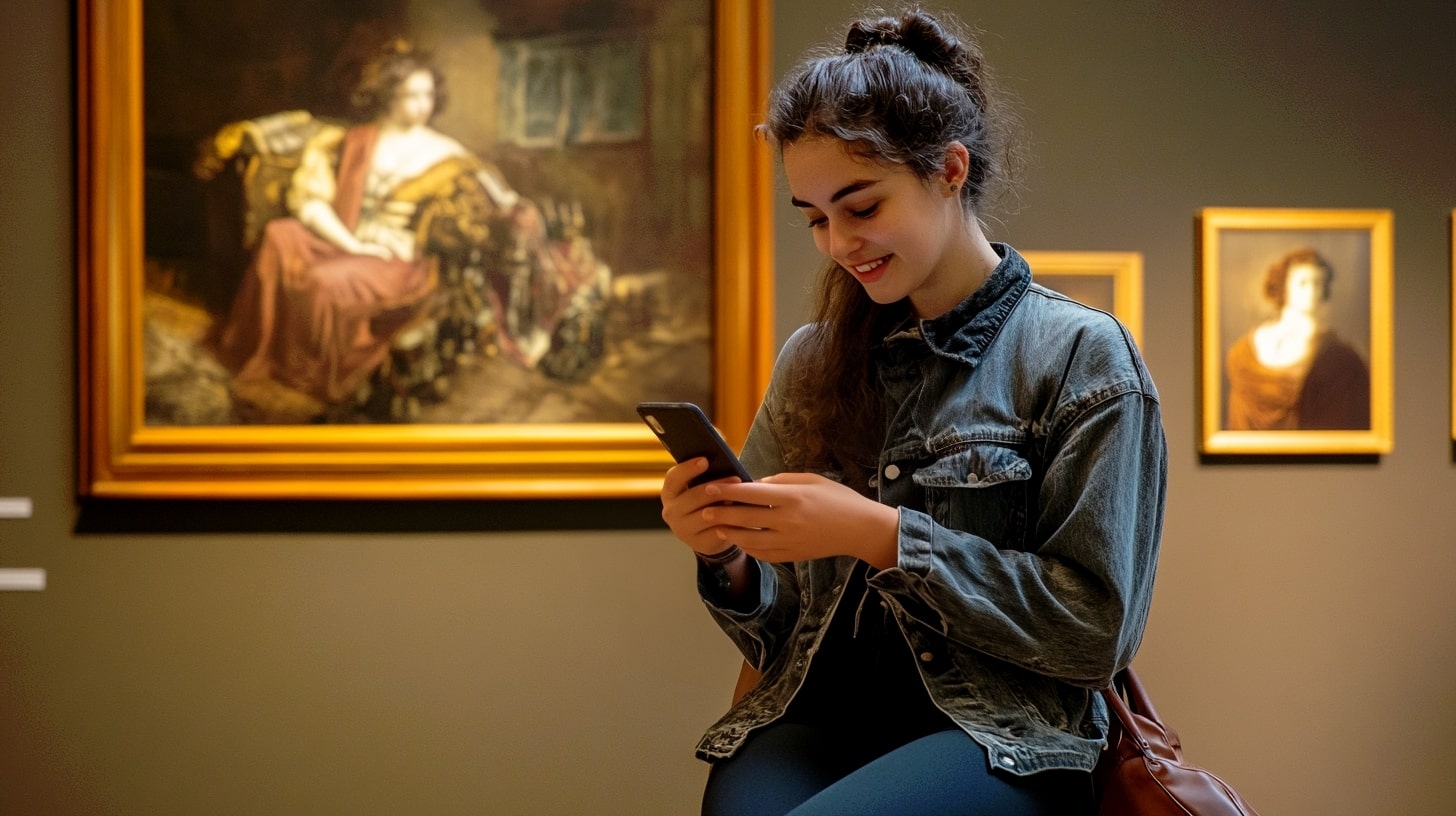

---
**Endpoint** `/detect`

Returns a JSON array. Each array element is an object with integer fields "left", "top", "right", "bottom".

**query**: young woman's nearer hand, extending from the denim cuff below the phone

[{"left": 695, "top": 471, "right": 900, "bottom": 570}]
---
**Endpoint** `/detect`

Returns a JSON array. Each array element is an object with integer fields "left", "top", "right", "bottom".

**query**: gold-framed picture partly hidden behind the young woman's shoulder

[{"left": 1022, "top": 249, "right": 1143, "bottom": 347}]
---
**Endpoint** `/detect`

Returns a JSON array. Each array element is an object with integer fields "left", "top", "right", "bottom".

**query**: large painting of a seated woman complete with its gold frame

[{"left": 77, "top": 0, "right": 773, "bottom": 498}]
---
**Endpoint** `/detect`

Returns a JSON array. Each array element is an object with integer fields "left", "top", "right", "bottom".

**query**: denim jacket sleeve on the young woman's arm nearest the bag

[{"left": 869, "top": 322, "right": 1168, "bottom": 688}]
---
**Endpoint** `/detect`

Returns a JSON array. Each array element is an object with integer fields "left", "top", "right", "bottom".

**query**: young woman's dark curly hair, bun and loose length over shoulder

[{"left": 759, "top": 9, "right": 1021, "bottom": 493}]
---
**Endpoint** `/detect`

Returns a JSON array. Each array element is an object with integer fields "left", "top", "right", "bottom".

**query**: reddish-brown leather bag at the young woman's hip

[{"left": 1092, "top": 666, "right": 1258, "bottom": 816}]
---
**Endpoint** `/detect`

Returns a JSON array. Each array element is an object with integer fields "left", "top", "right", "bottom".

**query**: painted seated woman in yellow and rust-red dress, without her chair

[{"left": 215, "top": 42, "right": 520, "bottom": 405}]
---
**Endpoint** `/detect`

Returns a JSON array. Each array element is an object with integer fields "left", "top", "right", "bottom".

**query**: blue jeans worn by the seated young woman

[{"left": 703, "top": 723, "right": 1092, "bottom": 816}]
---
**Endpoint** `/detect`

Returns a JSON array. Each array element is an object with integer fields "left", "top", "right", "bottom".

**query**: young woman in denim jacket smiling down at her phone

[{"left": 662, "top": 12, "right": 1166, "bottom": 816}]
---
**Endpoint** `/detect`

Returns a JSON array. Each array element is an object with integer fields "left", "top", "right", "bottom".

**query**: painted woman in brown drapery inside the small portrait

[{"left": 1226, "top": 249, "right": 1370, "bottom": 431}]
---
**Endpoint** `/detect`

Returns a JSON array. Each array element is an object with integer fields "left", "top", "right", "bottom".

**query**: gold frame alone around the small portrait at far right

[{"left": 1195, "top": 207, "right": 1395, "bottom": 455}]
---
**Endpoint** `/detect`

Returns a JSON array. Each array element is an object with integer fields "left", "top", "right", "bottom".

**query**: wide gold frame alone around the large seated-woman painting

[{"left": 77, "top": 0, "right": 775, "bottom": 500}]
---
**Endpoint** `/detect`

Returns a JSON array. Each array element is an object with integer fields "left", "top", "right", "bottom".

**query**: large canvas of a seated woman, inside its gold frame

[{"left": 143, "top": 0, "right": 716, "bottom": 427}]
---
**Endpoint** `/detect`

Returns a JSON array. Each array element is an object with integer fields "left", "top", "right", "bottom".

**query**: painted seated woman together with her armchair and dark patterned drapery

[{"left": 184, "top": 42, "right": 609, "bottom": 421}]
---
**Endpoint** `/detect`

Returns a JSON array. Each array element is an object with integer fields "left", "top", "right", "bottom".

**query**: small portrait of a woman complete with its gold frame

[{"left": 1197, "top": 208, "right": 1393, "bottom": 455}]
